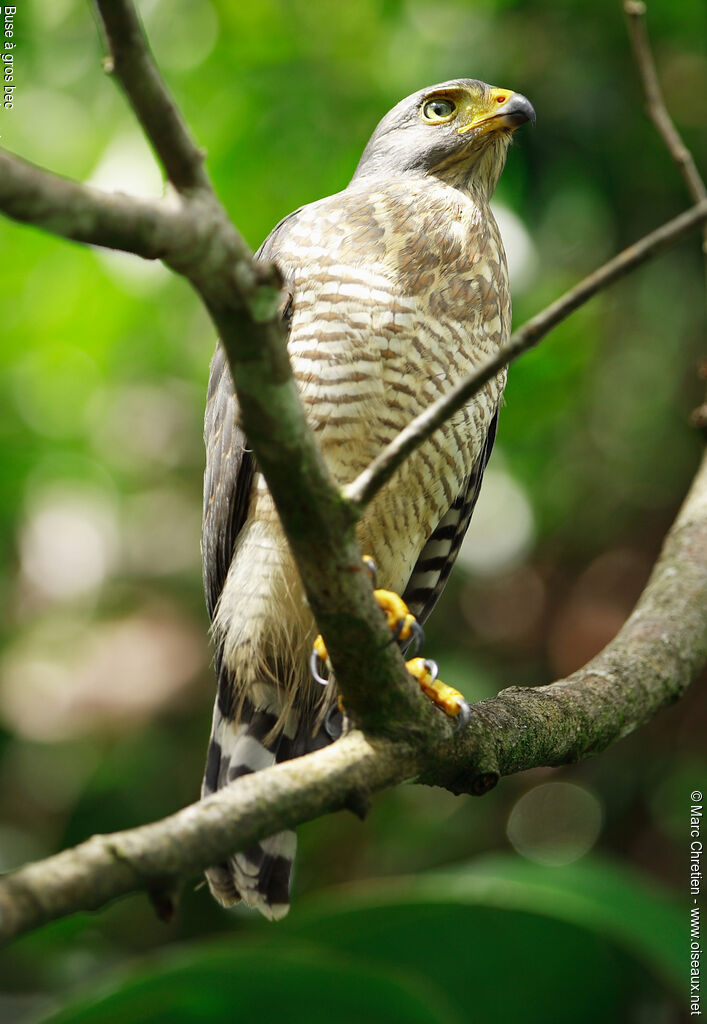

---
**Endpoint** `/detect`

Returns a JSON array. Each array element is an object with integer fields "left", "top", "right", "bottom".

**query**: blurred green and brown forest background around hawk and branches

[{"left": 0, "top": 0, "right": 707, "bottom": 1024}]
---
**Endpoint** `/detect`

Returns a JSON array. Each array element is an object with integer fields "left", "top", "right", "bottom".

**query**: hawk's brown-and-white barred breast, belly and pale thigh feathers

[{"left": 217, "top": 172, "right": 509, "bottom": 684}]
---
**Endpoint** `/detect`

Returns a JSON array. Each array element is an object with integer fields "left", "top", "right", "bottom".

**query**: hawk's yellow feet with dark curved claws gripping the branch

[{"left": 309, "top": 555, "right": 471, "bottom": 729}]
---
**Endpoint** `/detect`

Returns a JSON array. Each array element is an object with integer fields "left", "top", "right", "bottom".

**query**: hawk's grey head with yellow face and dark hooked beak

[{"left": 354, "top": 78, "right": 535, "bottom": 197}]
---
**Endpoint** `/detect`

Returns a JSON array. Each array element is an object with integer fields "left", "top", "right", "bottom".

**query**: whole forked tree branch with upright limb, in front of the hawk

[{"left": 0, "top": 0, "right": 707, "bottom": 950}]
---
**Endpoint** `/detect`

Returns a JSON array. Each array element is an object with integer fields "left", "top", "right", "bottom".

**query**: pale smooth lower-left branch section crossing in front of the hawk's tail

[{"left": 0, "top": 732, "right": 414, "bottom": 941}]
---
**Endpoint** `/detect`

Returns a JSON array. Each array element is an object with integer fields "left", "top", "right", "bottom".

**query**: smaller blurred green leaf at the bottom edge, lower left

[{"left": 38, "top": 931, "right": 459, "bottom": 1024}]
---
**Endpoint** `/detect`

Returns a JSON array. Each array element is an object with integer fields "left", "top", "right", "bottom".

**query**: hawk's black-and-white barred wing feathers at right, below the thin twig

[{"left": 403, "top": 411, "right": 498, "bottom": 623}]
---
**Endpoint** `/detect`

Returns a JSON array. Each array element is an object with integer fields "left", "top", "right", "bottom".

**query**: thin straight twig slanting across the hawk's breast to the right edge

[{"left": 344, "top": 200, "right": 707, "bottom": 510}]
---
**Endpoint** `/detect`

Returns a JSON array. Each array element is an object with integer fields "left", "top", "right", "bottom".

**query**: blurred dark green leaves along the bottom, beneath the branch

[{"left": 37, "top": 858, "right": 683, "bottom": 1024}]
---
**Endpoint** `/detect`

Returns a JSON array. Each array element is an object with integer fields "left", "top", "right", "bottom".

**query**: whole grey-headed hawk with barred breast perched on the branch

[{"left": 202, "top": 79, "right": 535, "bottom": 921}]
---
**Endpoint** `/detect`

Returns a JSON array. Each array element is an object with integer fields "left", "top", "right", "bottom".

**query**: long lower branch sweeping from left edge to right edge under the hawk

[{"left": 0, "top": 448, "right": 707, "bottom": 940}]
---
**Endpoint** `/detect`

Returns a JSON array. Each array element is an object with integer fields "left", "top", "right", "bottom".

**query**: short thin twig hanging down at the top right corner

[{"left": 623, "top": 0, "right": 707, "bottom": 282}]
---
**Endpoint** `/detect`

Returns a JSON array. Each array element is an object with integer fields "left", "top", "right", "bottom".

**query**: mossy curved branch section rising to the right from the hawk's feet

[{"left": 418, "top": 454, "right": 707, "bottom": 792}]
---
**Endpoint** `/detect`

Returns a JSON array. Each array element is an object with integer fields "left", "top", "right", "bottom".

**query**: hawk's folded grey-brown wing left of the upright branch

[{"left": 202, "top": 210, "right": 299, "bottom": 618}]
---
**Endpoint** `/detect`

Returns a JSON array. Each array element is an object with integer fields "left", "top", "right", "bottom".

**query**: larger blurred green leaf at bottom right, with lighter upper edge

[{"left": 278, "top": 857, "right": 684, "bottom": 1024}]
